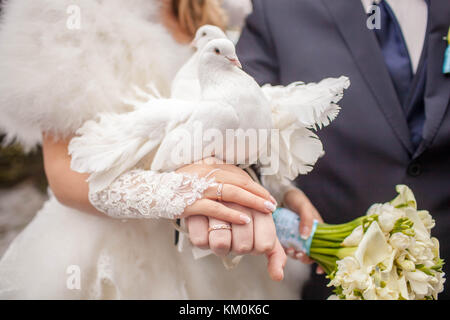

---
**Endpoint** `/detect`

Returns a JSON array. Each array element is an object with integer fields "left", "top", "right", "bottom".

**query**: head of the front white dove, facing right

[{"left": 200, "top": 39, "right": 242, "bottom": 70}]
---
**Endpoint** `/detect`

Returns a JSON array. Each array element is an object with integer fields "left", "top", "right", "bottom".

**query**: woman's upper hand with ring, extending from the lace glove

[{"left": 177, "top": 162, "right": 276, "bottom": 224}]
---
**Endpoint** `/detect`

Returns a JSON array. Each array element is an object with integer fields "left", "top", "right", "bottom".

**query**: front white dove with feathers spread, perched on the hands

[{"left": 69, "top": 39, "right": 349, "bottom": 194}]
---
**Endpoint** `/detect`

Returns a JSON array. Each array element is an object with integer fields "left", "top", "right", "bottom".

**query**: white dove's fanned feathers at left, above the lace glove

[{"left": 69, "top": 99, "right": 196, "bottom": 188}]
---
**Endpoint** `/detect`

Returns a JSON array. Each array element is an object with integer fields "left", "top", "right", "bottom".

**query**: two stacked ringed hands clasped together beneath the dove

[{"left": 178, "top": 161, "right": 286, "bottom": 281}]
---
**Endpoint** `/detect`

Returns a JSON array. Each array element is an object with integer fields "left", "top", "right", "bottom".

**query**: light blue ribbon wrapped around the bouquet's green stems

[{"left": 272, "top": 208, "right": 318, "bottom": 256}]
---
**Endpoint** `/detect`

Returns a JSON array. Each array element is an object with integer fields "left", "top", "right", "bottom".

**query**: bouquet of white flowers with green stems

[{"left": 274, "top": 185, "right": 445, "bottom": 300}]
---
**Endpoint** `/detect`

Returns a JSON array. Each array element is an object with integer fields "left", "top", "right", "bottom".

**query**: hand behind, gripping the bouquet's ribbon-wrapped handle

[{"left": 284, "top": 189, "right": 324, "bottom": 274}]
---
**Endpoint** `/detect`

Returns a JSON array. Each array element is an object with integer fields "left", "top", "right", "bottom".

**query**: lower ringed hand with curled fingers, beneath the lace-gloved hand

[{"left": 186, "top": 203, "right": 286, "bottom": 281}]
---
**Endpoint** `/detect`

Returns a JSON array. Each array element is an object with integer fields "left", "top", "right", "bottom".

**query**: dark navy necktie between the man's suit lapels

[{"left": 374, "top": 0, "right": 428, "bottom": 148}]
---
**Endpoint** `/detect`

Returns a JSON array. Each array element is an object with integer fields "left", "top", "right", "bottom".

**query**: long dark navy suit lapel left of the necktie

[{"left": 322, "top": 0, "right": 414, "bottom": 155}]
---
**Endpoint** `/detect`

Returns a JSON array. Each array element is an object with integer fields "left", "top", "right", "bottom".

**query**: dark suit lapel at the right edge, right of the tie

[{"left": 414, "top": 0, "right": 450, "bottom": 157}]
